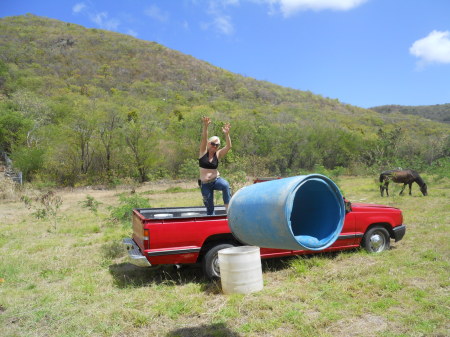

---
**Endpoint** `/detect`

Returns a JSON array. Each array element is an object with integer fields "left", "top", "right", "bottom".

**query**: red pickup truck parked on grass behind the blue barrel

[{"left": 123, "top": 193, "right": 406, "bottom": 278}]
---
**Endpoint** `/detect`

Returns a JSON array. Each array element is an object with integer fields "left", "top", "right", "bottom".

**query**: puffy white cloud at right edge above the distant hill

[{"left": 409, "top": 30, "right": 450, "bottom": 65}]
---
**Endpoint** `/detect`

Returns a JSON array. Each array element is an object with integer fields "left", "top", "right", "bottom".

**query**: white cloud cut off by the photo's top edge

[{"left": 256, "top": 0, "right": 368, "bottom": 17}]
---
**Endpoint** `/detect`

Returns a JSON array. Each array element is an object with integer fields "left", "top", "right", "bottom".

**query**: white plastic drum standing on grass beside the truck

[{"left": 218, "top": 246, "right": 263, "bottom": 294}]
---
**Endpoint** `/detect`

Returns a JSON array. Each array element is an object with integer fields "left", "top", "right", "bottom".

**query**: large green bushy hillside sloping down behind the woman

[{"left": 0, "top": 15, "right": 450, "bottom": 185}]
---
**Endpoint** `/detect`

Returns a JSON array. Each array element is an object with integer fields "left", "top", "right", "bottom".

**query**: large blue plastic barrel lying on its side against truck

[{"left": 228, "top": 174, "right": 345, "bottom": 250}]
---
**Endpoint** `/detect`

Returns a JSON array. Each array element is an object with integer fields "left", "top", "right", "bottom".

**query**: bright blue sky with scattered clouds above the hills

[{"left": 0, "top": 0, "right": 450, "bottom": 108}]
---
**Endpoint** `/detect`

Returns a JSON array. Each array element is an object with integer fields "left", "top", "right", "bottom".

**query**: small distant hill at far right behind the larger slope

[{"left": 370, "top": 103, "right": 450, "bottom": 123}]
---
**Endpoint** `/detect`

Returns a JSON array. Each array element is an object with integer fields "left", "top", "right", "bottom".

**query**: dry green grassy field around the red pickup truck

[{"left": 0, "top": 176, "right": 450, "bottom": 337}]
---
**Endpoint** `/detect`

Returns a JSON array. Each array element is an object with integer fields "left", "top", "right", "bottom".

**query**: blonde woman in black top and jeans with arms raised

[{"left": 198, "top": 117, "right": 231, "bottom": 215}]
